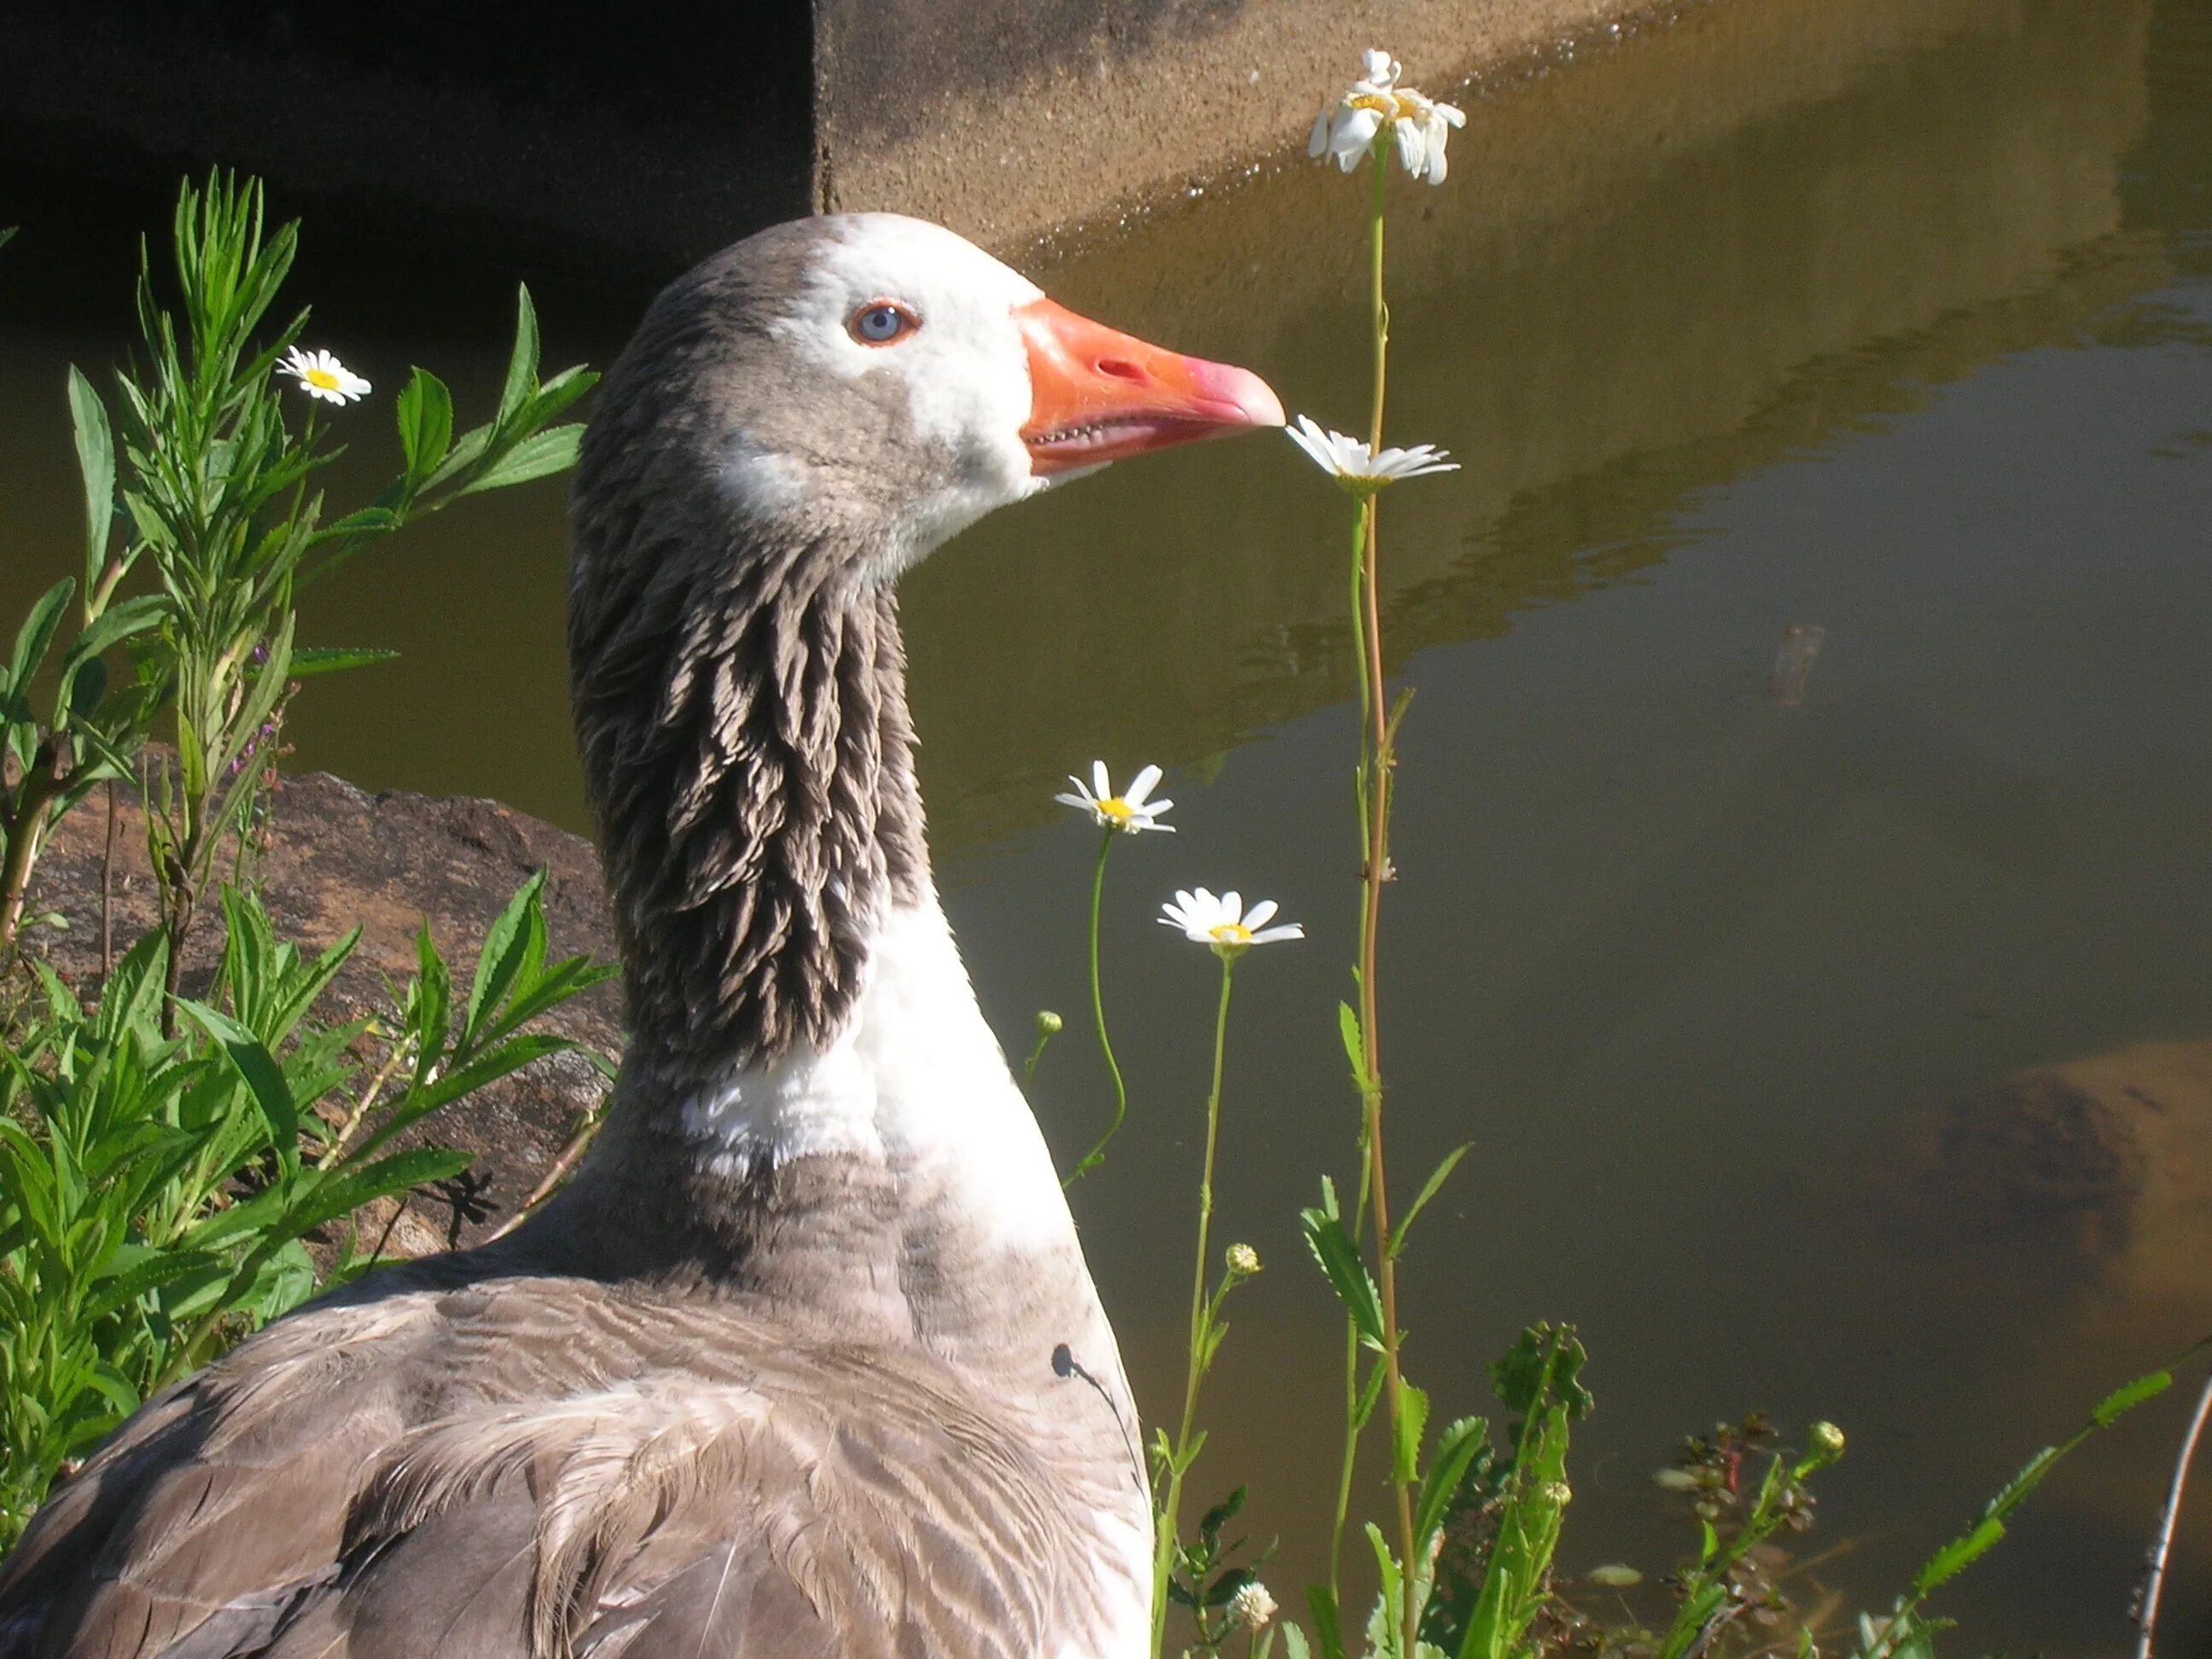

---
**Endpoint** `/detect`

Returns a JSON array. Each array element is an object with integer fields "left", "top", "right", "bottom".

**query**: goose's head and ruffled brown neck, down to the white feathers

[{"left": 568, "top": 214, "right": 1283, "bottom": 1071}]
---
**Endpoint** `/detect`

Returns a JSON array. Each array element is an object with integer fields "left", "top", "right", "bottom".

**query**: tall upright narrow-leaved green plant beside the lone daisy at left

[{"left": 0, "top": 172, "right": 597, "bottom": 999}]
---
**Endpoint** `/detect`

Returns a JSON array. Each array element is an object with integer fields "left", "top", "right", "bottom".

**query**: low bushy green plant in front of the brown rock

[{"left": 0, "top": 876, "right": 610, "bottom": 1546}]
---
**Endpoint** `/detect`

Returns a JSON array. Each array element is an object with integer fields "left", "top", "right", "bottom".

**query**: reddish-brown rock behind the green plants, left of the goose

[{"left": 26, "top": 772, "right": 624, "bottom": 1254}]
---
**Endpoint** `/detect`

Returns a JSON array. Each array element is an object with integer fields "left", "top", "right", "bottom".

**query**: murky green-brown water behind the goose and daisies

[{"left": 0, "top": 0, "right": 2212, "bottom": 1655}]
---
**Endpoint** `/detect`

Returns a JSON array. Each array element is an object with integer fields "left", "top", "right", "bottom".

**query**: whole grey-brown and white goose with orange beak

[{"left": 0, "top": 214, "right": 1283, "bottom": 1659}]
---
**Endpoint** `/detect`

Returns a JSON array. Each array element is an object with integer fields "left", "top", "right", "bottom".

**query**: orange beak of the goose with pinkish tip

[{"left": 1013, "top": 299, "right": 1283, "bottom": 478}]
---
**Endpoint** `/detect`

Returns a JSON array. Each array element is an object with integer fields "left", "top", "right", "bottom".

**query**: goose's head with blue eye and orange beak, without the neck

[{"left": 579, "top": 212, "right": 1283, "bottom": 592}]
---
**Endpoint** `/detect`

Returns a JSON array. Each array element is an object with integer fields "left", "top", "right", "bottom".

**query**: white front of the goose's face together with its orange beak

[{"left": 756, "top": 212, "right": 1283, "bottom": 564}]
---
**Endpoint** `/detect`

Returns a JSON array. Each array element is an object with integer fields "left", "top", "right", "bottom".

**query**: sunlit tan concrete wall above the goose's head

[{"left": 814, "top": 0, "right": 1655, "bottom": 247}]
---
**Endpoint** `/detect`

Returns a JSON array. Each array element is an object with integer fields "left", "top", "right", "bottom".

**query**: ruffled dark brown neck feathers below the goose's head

[{"left": 568, "top": 524, "right": 927, "bottom": 1092}]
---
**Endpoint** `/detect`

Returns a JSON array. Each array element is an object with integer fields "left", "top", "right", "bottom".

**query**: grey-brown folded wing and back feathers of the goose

[{"left": 0, "top": 1281, "right": 1091, "bottom": 1659}]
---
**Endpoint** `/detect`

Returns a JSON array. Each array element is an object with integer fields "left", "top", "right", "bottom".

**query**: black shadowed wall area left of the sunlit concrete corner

[{"left": 0, "top": 0, "right": 814, "bottom": 276}]
